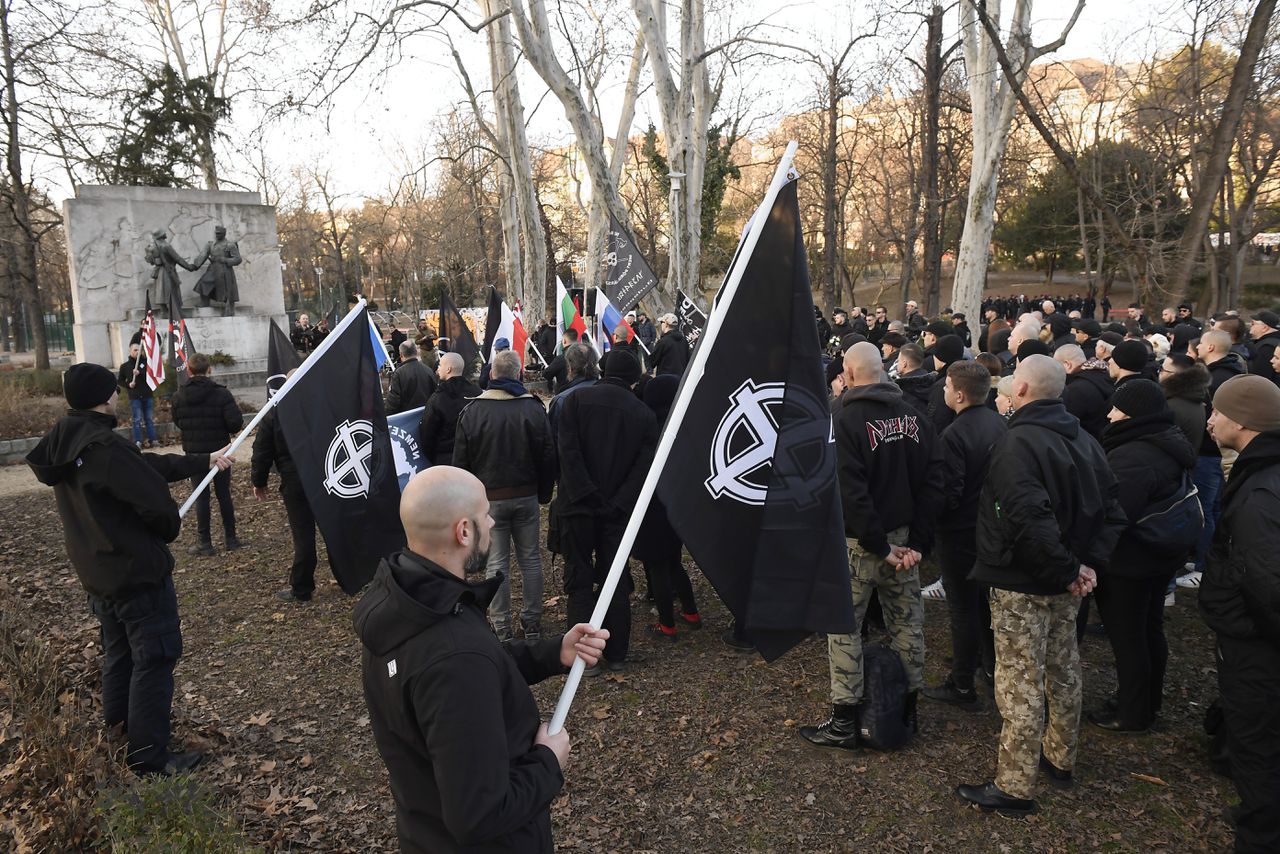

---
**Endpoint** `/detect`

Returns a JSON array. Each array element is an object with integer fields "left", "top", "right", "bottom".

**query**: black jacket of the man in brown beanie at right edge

[{"left": 1199, "top": 430, "right": 1280, "bottom": 656}]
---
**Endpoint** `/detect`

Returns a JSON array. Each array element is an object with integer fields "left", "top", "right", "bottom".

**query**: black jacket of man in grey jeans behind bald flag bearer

[{"left": 453, "top": 385, "right": 556, "bottom": 504}]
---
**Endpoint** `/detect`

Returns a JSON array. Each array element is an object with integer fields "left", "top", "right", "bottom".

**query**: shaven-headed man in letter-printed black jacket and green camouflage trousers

[{"left": 800, "top": 342, "right": 942, "bottom": 750}]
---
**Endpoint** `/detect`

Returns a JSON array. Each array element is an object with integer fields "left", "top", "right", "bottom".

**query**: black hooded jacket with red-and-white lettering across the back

[{"left": 832, "top": 383, "right": 943, "bottom": 557}]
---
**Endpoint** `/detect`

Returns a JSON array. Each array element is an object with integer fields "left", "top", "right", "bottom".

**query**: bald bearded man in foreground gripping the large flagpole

[{"left": 355, "top": 466, "right": 609, "bottom": 853}]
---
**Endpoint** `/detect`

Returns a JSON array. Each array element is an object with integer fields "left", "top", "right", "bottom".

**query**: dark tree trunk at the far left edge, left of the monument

[{"left": 0, "top": 3, "right": 49, "bottom": 370}]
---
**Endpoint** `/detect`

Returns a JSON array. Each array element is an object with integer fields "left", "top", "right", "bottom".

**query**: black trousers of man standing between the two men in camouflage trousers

[{"left": 937, "top": 528, "right": 996, "bottom": 689}]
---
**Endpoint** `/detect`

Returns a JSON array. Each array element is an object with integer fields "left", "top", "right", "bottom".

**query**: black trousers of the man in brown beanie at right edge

[{"left": 1217, "top": 635, "right": 1280, "bottom": 854}]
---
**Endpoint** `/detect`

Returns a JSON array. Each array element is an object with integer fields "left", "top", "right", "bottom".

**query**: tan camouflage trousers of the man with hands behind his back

[{"left": 991, "top": 589, "right": 1080, "bottom": 798}]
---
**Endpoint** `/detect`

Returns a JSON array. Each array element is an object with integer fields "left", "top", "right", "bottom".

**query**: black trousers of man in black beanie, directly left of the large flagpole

[{"left": 559, "top": 516, "right": 635, "bottom": 661}]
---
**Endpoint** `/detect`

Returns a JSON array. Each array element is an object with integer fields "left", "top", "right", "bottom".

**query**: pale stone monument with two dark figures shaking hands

[{"left": 63, "top": 186, "right": 288, "bottom": 385}]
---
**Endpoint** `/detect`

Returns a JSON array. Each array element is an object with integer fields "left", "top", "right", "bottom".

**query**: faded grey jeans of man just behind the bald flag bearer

[{"left": 485, "top": 495, "right": 543, "bottom": 632}]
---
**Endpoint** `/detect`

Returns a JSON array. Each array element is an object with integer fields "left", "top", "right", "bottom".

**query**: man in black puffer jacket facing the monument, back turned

[{"left": 173, "top": 353, "right": 244, "bottom": 557}]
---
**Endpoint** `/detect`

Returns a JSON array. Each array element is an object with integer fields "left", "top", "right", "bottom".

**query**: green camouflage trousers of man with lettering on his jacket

[{"left": 827, "top": 528, "right": 924, "bottom": 705}]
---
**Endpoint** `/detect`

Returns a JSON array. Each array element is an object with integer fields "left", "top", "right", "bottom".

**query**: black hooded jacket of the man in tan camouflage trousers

[{"left": 970, "top": 398, "right": 1128, "bottom": 595}]
